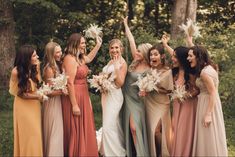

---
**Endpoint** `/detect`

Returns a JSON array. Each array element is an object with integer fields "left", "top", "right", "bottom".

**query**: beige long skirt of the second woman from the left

[{"left": 43, "top": 70, "right": 64, "bottom": 156}]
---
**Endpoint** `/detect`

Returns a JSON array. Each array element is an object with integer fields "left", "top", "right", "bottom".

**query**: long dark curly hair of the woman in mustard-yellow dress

[{"left": 14, "top": 45, "right": 39, "bottom": 95}]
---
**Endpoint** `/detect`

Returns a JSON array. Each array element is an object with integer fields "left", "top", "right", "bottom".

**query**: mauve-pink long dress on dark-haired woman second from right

[{"left": 171, "top": 81, "right": 197, "bottom": 156}]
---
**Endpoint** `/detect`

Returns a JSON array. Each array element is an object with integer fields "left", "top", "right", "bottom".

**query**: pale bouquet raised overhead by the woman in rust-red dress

[{"left": 85, "top": 24, "right": 102, "bottom": 39}]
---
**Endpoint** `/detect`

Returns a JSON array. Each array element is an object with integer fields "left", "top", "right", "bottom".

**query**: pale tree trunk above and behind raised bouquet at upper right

[{"left": 171, "top": 0, "right": 197, "bottom": 39}]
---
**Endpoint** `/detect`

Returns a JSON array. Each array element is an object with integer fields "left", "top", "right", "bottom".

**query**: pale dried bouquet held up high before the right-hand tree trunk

[{"left": 179, "top": 19, "right": 201, "bottom": 38}]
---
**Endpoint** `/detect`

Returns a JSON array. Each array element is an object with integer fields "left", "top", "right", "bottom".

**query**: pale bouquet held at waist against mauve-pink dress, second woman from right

[{"left": 170, "top": 85, "right": 190, "bottom": 102}]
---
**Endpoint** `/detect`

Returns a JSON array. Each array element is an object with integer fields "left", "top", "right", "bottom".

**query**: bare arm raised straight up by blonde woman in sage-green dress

[{"left": 123, "top": 16, "right": 137, "bottom": 59}]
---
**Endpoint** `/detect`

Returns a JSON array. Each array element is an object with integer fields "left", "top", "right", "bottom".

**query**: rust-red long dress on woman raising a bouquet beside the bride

[{"left": 62, "top": 64, "right": 98, "bottom": 156}]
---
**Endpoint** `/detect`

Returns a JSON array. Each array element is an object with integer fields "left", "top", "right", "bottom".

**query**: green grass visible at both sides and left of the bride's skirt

[{"left": 0, "top": 95, "right": 235, "bottom": 157}]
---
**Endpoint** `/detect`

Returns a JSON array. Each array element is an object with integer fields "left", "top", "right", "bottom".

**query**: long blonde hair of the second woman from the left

[{"left": 43, "top": 41, "right": 60, "bottom": 75}]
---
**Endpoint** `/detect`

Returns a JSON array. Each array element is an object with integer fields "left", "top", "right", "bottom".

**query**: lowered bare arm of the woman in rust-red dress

[{"left": 63, "top": 55, "right": 80, "bottom": 115}]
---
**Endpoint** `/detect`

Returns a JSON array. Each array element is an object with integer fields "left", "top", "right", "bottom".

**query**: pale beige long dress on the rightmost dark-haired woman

[{"left": 192, "top": 65, "right": 228, "bottom": 156}]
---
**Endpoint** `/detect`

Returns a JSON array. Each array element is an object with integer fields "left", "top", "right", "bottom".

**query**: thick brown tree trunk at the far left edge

[{"left": 0, "top": 0, "right": 15, "bottom": 88}]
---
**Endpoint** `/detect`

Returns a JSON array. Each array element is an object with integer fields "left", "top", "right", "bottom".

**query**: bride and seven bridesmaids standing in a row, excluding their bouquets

[{"left": 9, "top": 17, "right": 228, "bottom": 156}]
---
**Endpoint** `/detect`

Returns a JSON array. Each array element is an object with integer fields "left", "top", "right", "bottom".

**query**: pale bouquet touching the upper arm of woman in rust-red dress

[{"left": 50, "top": 72, "right": 68, "bottom": 91}]
